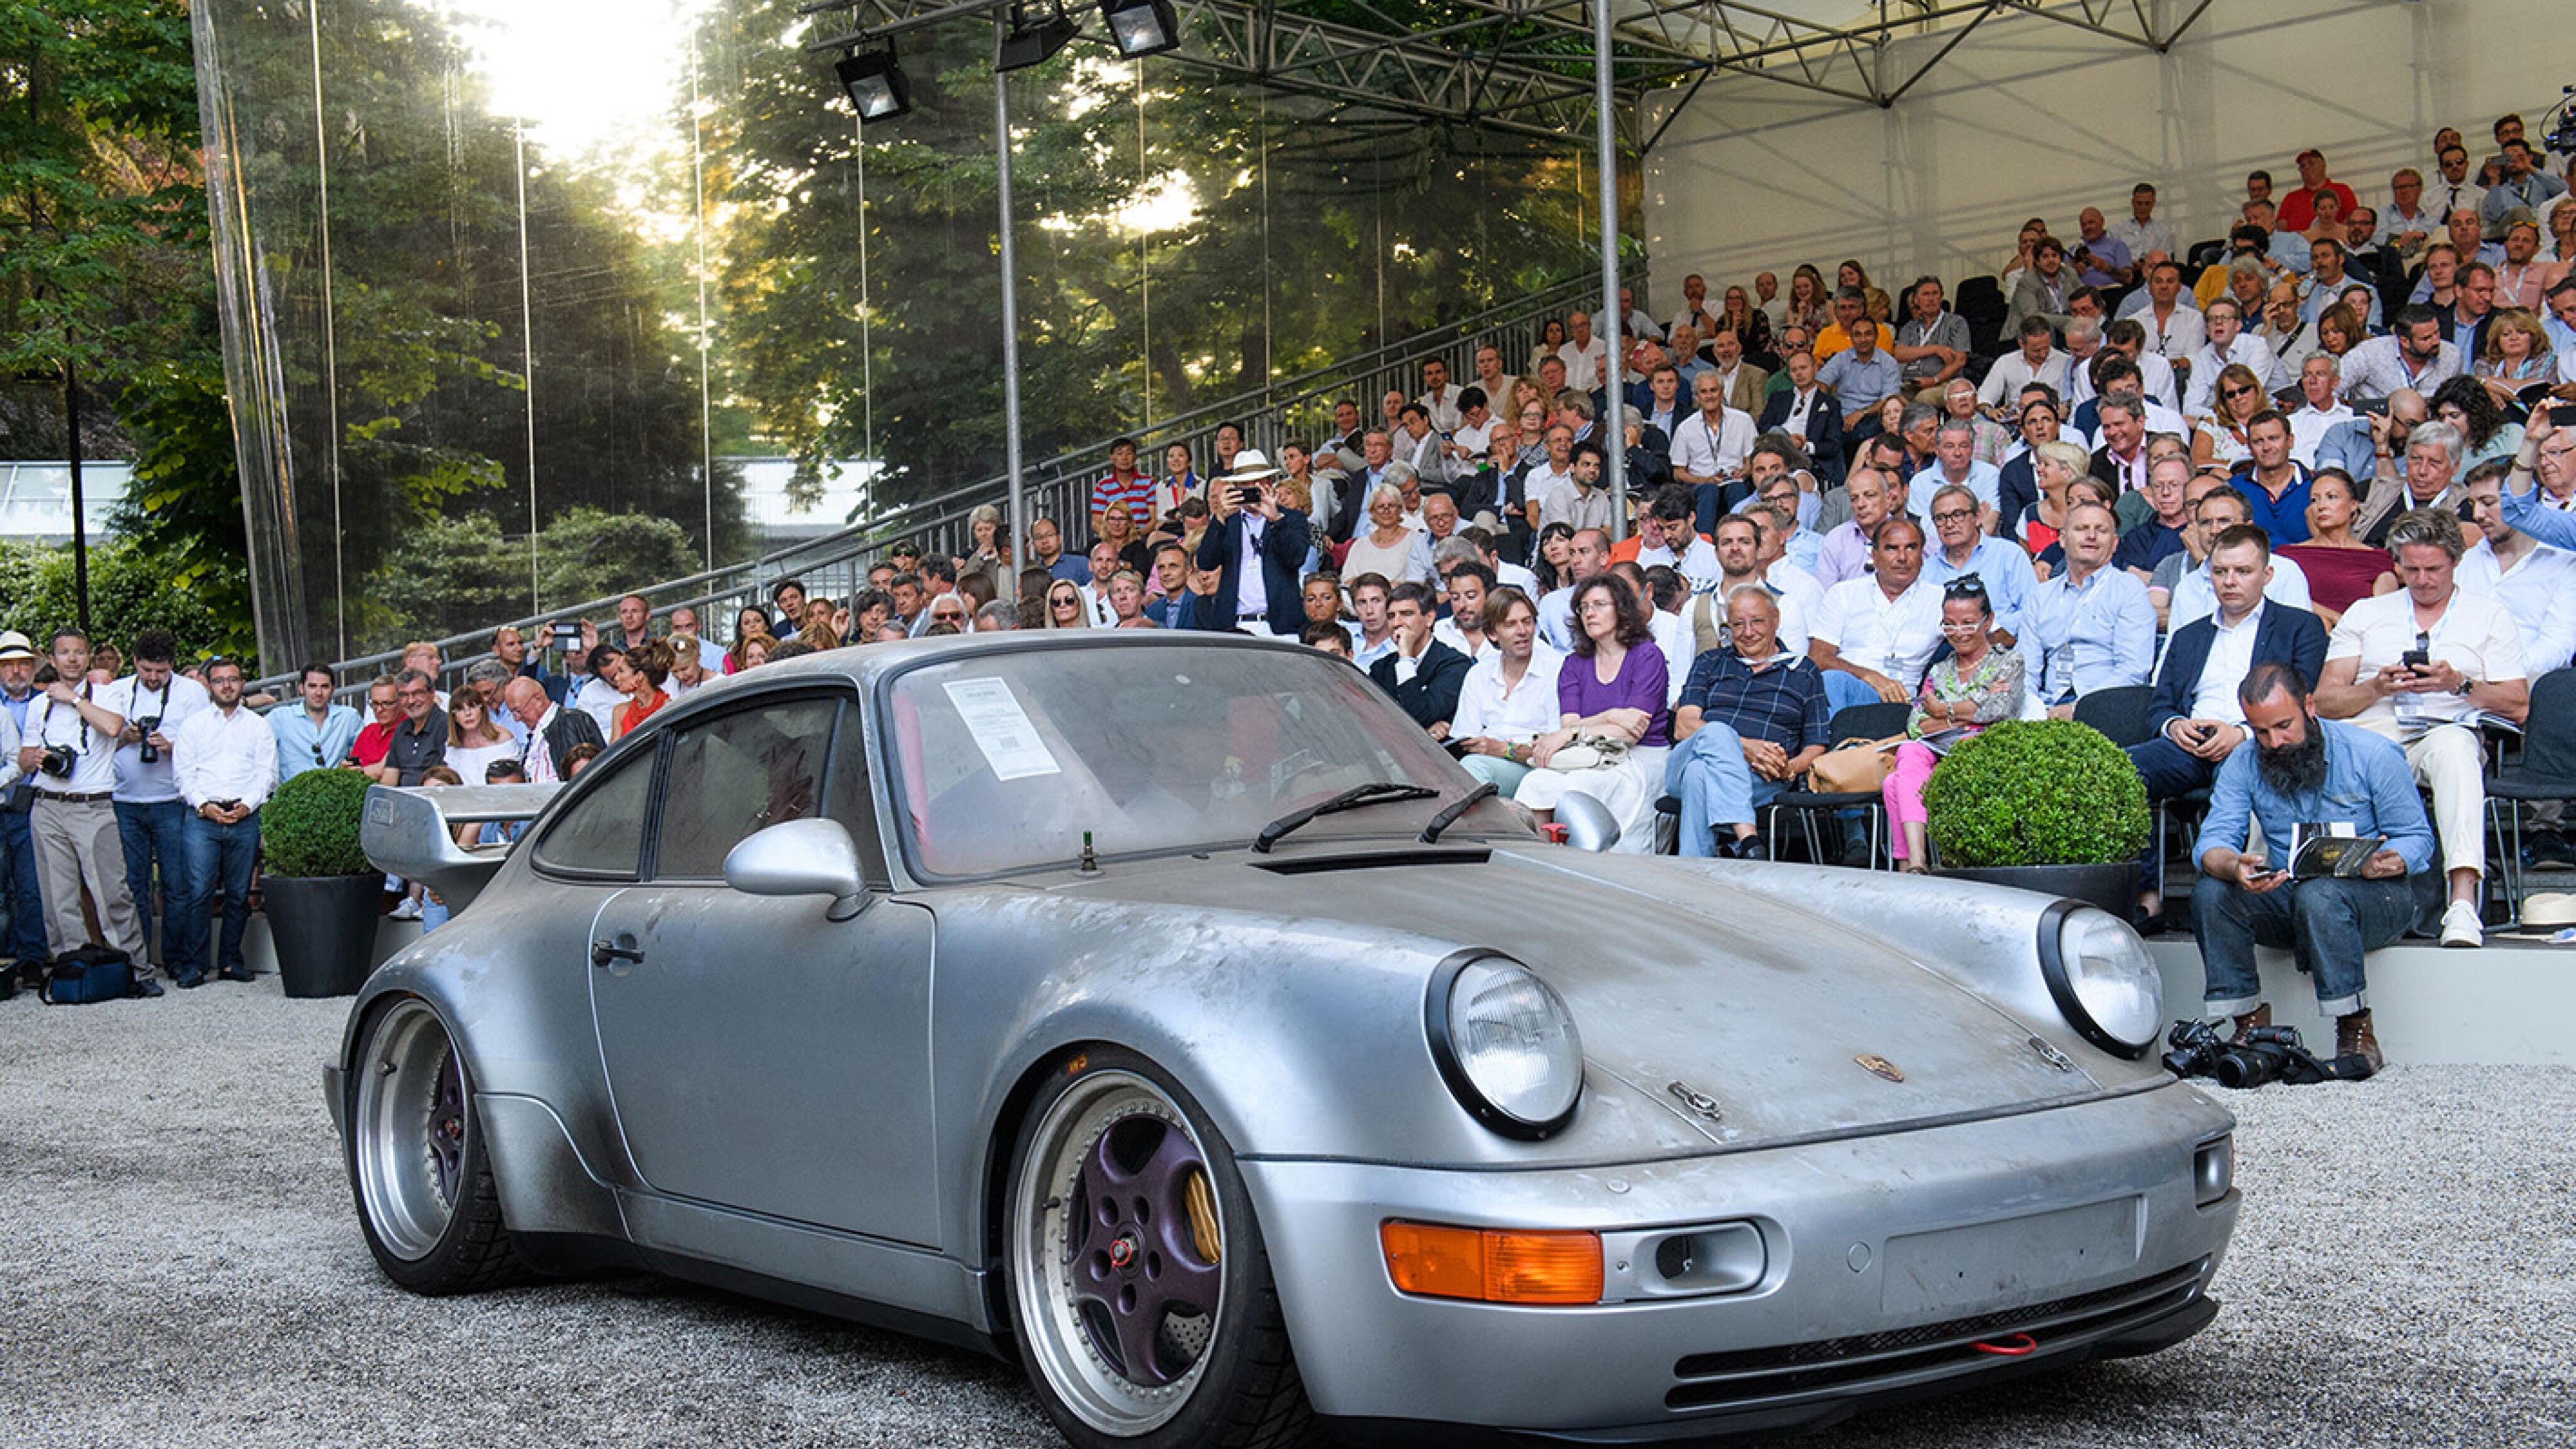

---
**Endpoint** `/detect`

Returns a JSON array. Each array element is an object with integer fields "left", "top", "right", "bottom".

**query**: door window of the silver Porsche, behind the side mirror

[{"left": 654, "top": 696, "right": 840, "bottom": 879}]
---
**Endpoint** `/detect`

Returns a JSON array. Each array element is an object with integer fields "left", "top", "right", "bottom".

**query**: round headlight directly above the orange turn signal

[{"left": 1422, "top": 954, "right": 1584, "bottom": 1137}]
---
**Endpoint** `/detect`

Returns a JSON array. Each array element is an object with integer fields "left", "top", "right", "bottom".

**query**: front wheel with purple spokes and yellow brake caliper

[{"left": 1004, "top": 1046, "right": 1321, "bottom": 1449}]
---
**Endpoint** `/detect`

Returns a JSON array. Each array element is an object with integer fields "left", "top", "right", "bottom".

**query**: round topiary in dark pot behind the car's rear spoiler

[{"left": 260, "top": 771, "right": 384, "bottom": 995}]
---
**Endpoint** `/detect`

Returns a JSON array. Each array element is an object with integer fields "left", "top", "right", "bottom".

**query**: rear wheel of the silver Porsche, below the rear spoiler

[{"left": 348, "top": 998, "right": 528, "bottom": 1297}]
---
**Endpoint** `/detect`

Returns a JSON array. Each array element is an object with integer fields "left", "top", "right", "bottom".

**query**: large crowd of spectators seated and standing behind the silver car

[{"left": 0, "top": 119, "right": 2576, "bottom": 1062}]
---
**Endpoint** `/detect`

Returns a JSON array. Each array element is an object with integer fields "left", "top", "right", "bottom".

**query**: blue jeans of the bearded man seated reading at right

[{"left": 2192, "top": 872, "right": 2442, "bottom": 1018}]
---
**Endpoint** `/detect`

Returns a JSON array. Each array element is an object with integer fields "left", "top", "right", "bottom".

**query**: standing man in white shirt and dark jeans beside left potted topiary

[{"left": 165, "top": 657, "right": 272, "bottom": 987}]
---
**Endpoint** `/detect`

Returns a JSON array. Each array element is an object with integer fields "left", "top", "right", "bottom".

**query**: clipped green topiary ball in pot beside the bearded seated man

[{"left": 1924, "top": 719, "right": 2151, "bottom": 921}]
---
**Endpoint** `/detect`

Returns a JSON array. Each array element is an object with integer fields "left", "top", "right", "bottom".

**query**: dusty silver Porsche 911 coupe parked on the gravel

[{"left": 327, "top": 631, "right": 2238, "bottom": 1446}]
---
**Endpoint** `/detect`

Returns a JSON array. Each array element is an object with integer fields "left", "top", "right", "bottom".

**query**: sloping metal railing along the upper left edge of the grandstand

[{"left": 250, "top": 265, "right": 1646, "bottom": 699}]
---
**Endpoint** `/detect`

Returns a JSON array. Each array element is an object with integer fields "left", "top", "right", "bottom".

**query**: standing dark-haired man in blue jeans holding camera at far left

[{"left": 98, "top": 629, "right": 206, "bottom": 987}]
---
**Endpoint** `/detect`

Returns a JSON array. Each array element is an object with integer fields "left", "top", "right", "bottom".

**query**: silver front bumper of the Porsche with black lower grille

[{"left": 1241, "top": 1083, "right": 2238, "bottom": 1444}]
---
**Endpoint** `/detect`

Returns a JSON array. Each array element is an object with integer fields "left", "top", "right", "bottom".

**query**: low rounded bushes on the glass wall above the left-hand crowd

[{"left": 369, "top": 508, "right": 698, "bottom": 640}]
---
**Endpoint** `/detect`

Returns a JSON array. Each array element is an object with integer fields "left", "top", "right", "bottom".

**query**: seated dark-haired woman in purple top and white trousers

[{"left": 1512, "top": 572, "right": 1672, "bottom": 853}]
